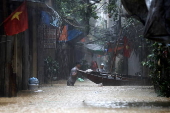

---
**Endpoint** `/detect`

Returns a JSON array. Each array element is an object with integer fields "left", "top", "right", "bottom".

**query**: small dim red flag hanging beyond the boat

[{"left": 123, "top": 37, "right": 131, "bottom": 58}]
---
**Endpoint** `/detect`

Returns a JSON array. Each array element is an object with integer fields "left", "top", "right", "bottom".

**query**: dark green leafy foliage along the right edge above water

[{"left": 142, "top": 42, "right": 170, "bottom": 97}]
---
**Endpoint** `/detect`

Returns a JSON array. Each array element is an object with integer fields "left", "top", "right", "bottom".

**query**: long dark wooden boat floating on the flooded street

[{"left": 78, "top": 70, "right": 151, "bottom": 86}]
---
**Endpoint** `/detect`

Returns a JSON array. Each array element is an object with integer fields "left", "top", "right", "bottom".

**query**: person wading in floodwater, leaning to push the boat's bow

[{"left": 67, "top": 62, "right": 81, "bottom": 86}]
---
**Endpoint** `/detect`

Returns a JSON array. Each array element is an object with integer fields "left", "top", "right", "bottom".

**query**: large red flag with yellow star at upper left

[{"left": 4, "top": 2, "right": 28, "bottom": 35}]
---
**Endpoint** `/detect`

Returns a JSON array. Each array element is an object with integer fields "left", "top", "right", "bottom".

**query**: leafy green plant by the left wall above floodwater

[{"left": 44, "top": 56, "right": 59, "bottom": 85}]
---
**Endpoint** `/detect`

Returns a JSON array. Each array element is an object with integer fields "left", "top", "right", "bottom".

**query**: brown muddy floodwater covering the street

[{"left": 0, "top": 80, "right": 170, "bottom": 113}]
